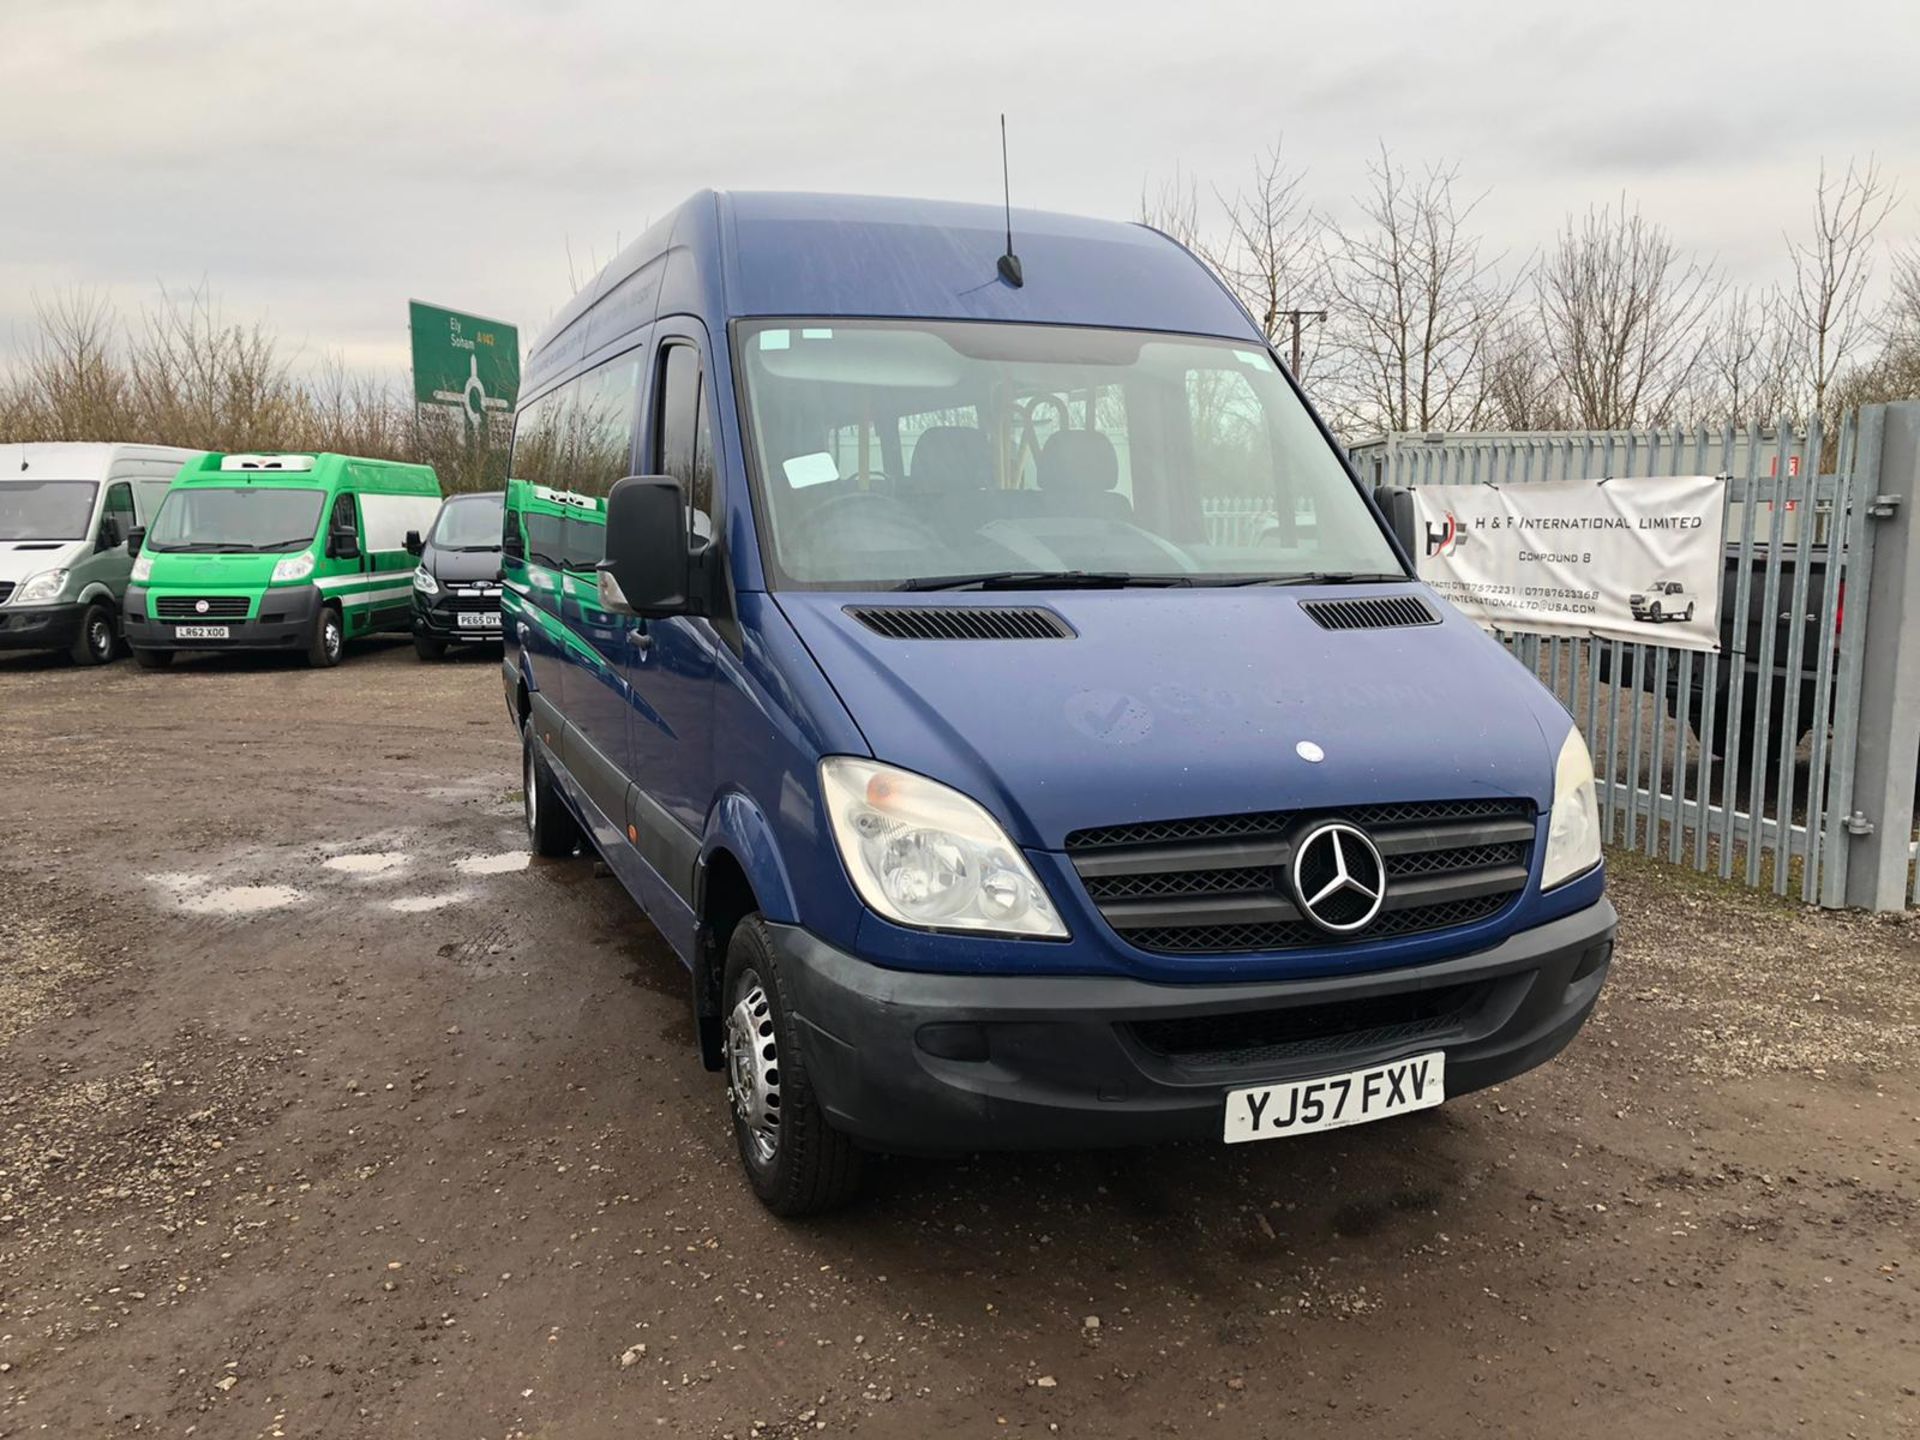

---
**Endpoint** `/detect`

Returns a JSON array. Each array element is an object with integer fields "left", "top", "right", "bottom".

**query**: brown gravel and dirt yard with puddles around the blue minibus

[{"left": 0, "top": 645, "right": 1920, "bottom": 1440}]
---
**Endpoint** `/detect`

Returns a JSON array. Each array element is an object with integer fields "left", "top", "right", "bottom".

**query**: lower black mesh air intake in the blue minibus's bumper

[{"left": 1127, "top": 981, "right": 1492, "bottom": 1066}]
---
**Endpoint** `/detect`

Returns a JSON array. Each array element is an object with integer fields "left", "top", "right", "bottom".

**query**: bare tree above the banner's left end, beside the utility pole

[{"left": 1327, "top": 146, "right": 1515, "bottom": 439}]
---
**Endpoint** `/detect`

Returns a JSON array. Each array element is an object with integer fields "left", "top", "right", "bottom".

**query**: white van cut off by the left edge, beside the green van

[{"left": 0, "top": 444, "right": 204, "bottom": 664}]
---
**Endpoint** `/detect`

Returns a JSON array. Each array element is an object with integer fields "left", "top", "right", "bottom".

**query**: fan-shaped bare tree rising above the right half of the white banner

[{"left": 1534, "top": 198, "right": 1722, "bottom": 430}]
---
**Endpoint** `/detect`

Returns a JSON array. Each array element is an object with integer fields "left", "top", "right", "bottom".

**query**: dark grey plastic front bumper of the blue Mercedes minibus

[{"left": 770, "top": 900, "right": 1615, "bottom": 1152}]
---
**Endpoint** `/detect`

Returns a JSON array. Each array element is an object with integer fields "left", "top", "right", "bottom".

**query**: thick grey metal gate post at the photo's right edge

[{"left": 1843, "top": 401, "right": 1920, "bottom": 910}]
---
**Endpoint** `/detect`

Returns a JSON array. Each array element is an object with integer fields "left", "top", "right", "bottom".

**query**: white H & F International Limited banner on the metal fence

[{"left": 1413, "top": 474, "right": 1726, "bottom": 651}]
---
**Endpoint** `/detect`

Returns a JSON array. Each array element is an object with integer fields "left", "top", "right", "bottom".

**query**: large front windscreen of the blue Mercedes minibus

[{"left": 737, "top": 321, "right": 1405, "bottom": 589}]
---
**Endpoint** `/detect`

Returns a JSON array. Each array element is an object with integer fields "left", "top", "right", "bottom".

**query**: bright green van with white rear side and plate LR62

[{"left": 127, "top": 453, "right": 440, "bottom": 670}]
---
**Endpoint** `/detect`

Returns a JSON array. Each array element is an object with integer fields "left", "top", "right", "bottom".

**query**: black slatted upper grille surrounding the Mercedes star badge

[{"left": 1068, "top": 801, "right": 1534, "bottom": 954}]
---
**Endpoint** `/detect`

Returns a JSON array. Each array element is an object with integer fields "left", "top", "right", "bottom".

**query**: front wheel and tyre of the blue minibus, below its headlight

[{"left": 720, "top": 914, "right": 862, "bottom": 1219}]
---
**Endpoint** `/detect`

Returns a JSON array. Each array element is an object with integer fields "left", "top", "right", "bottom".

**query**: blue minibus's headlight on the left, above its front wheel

[{"left": 820, "top": 756, "right": 1068, "bottom": 939}]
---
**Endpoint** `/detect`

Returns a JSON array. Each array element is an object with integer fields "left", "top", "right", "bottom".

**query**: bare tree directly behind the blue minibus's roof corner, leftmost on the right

[{"left": 1200, "top": 140, "right": 1321, "bottom": 380}]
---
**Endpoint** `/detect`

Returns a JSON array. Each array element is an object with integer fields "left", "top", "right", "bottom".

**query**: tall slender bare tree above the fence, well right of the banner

[{"left": 1788, "top": 156, "right": 1895, "bottom": 426}]
